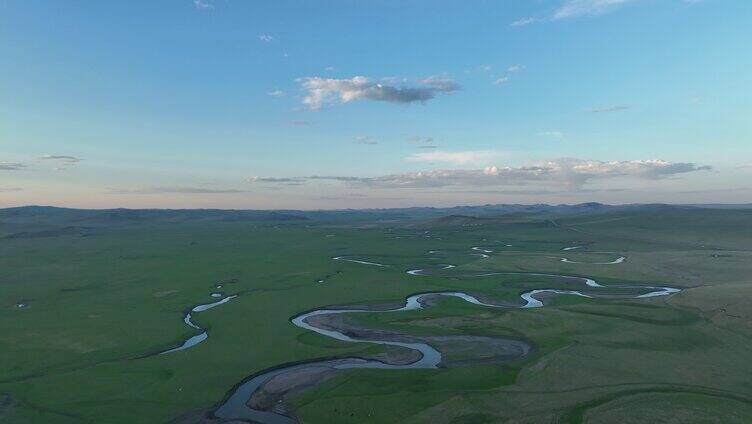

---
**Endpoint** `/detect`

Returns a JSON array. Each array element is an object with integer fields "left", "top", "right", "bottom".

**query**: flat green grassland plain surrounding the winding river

[{"left": 0, "top": 207, "right": 752, "bottom": 423}]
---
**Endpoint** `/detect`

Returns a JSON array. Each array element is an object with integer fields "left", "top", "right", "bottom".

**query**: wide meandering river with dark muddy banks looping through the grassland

[{"left": 210, "top": 247, "right": 680, "bottom": 424}]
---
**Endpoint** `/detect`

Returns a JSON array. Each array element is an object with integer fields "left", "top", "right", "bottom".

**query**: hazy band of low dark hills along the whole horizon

[{"left": 0, "top": 203, "right": 752, "bottom": 243}]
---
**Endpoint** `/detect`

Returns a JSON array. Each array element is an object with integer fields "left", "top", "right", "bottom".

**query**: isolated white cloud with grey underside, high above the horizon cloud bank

[{"left": 299, "top": 76, "right": 460, "bottom": 110}]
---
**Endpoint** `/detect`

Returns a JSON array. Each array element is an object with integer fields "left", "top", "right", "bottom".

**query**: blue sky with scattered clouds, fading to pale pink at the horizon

[{"left": 0, "top": 0, "right": 752, "bottom": 209}]
